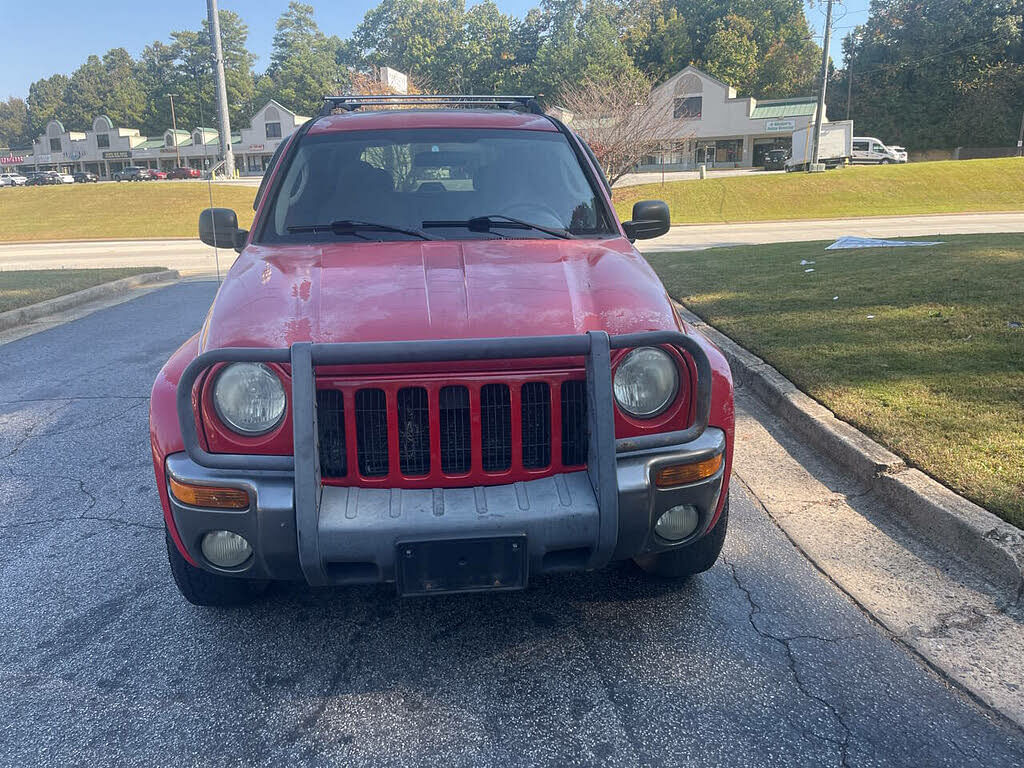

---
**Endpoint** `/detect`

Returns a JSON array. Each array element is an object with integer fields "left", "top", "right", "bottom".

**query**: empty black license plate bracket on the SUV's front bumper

[{"left": 395, "top": 536, "right": 527, "bottom": 596}]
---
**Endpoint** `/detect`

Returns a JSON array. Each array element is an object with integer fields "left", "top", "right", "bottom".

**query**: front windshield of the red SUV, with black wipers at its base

[{"left": 260, "top": 128, "right": 615, "bottom": 243}]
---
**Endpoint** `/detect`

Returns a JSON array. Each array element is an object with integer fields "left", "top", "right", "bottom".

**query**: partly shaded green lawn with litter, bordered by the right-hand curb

[{"left": 648, "top": 234, "right": 1024, "bottom": 527}]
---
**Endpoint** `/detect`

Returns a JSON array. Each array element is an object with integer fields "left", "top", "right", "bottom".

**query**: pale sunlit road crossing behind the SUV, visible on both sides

[{"left": 0, "top": 213, "right": 1024, "bottom": 275}]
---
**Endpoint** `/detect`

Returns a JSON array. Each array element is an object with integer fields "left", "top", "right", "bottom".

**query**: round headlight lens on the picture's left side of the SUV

[{"left": 213, "top": 362, "right": 285, "bottom": 435}]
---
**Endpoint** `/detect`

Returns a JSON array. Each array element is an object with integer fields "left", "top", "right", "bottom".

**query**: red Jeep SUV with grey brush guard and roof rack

[{"left": 151, "top": 96, "right": 733, "bottom": 605}]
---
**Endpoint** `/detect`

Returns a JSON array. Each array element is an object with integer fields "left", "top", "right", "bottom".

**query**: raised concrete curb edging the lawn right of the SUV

[{"left": 676, "top": 302, "right": 1024, "bottom": 600}]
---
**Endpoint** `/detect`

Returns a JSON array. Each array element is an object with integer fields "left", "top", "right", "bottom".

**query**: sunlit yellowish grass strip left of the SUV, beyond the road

[{"left": 0, "top": 181, "right": 256, "bottom": 243}]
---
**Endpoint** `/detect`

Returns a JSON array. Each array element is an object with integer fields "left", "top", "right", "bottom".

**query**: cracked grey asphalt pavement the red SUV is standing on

[{"left": 0, "top": 281, "right": 1024, "bottom": 768}]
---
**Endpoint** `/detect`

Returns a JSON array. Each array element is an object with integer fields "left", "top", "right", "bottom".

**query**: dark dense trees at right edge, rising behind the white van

[{"left": 829, "top": 0, "right": 1024, "bottom": 148}]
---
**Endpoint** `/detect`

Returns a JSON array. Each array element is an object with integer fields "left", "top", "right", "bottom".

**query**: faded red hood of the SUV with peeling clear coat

[{"left": 201, "top": 238, "right": 677, "bottom": 349}]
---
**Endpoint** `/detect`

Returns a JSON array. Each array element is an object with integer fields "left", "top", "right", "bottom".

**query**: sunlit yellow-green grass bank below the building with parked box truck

[{"left": 614, "top": 158, "right": 1024, "bottom": 224}]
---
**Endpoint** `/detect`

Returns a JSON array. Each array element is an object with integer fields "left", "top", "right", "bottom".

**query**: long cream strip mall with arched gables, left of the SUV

[{"left": 0, "top": 100, "right": 309, "bottom": 178}]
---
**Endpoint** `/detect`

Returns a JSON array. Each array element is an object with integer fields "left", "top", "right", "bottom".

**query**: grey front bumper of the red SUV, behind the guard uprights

[{"left": 167, "top": 427, "right": 726, "bottom": 585}]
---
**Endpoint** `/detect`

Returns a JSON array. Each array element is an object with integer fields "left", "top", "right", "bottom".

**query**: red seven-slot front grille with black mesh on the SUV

[{"left": 316, "top": 377, "right": 588, "bottom": 482}]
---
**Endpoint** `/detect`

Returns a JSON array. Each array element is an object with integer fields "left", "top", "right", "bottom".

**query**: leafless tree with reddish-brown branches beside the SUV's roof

[{"left": 560, "top": 71, "right": 678, "bottom": 184}]
